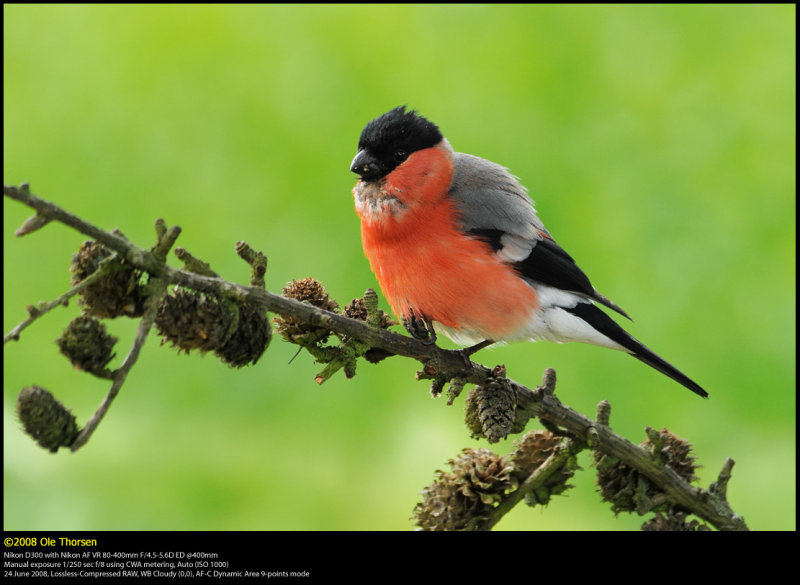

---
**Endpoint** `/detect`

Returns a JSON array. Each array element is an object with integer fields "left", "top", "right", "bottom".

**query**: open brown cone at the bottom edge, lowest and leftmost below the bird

[{"left": 414, "top": 449, "right": 517, "bottom": 530}]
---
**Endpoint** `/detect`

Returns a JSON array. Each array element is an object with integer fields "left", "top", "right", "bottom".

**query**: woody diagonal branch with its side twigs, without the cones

[{"left": 3, "top": 184, "right": 747, "bottom": 530}]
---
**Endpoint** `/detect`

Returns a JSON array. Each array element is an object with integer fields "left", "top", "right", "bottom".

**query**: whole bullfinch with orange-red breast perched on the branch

[{"left": 350, "top": 106, "right": 708, "bottom": 397}]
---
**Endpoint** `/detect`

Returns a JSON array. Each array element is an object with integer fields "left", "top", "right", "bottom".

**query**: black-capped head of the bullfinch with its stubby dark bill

[{"left": 350, "top": 106, "right": 443, "bottom": 181}]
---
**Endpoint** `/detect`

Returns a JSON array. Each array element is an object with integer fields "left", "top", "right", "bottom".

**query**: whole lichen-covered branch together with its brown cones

[{"left": 3, "top": 184, "right": 747, "bottom": 530}]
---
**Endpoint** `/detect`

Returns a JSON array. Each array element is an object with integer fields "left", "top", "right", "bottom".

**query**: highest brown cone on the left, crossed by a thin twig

[{"left": 70, "top": 240, "right": 146, "bottom": 319}]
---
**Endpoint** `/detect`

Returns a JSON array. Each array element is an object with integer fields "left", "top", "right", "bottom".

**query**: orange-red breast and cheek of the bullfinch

[{"left": 354, "top": 143, "right": 538, "bottom": 339}]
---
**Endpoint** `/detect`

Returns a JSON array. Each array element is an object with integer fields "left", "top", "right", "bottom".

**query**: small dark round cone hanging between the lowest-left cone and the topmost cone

[{"left": 56, "top": 315, "right": 117, "bottom": 377}]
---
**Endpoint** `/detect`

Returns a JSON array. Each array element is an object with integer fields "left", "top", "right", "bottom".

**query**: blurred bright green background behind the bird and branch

[{"left": 3, "top": 5, "right": 796, "bottom": 530}]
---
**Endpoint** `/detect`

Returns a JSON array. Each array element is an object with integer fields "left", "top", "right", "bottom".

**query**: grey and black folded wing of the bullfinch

[{"left": 449, "top": 153, "right": 630, "bottom": 319}]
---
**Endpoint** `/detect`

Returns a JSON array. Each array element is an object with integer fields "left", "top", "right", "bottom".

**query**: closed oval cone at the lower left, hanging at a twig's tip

[{"left": 17, "top": 386, "right": 80, "bottom": 453}]
